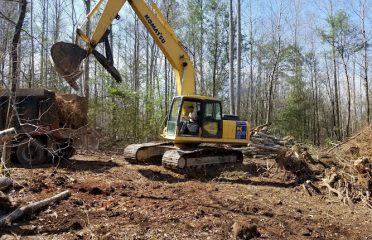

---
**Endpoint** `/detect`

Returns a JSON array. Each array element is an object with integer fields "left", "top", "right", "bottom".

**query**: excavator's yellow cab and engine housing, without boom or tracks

[{"left": 164, "top": 95, "right": 250, "bottom": 145}]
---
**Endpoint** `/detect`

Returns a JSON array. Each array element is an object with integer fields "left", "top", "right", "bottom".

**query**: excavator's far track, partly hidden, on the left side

[{"left": 124, "top": 142, "right": 174, "bottom": 164}]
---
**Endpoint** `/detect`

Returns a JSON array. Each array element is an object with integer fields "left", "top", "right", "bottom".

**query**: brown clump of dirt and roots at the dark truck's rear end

[{"left": 56, "top": 94, "right": 88, "bottom": 129}]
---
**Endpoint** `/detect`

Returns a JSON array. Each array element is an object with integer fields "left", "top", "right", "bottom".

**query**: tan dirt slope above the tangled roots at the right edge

[{"left": 331, "top": 126, "right": 372, "bottom": 160}]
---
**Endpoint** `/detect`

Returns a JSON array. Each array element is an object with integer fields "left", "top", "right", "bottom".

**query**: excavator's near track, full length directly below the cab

[{"left": 162, "top": 147, "right": 243, "bottom": 171}]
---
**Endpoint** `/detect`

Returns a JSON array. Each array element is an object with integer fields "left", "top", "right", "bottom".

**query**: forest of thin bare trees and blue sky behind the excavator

[{"left": 0, "top": 0, "right": 372, "bottom": 145}]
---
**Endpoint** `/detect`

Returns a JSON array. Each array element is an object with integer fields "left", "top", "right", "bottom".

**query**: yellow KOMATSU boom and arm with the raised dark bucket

[{"left": 52, "top": 0, "right": 195, "bottom": 96}]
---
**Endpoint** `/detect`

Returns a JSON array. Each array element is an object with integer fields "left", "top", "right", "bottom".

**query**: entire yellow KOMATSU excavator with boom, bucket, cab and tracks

[{"left": 51, "top": 0, "right": 250, "bottom": 170}]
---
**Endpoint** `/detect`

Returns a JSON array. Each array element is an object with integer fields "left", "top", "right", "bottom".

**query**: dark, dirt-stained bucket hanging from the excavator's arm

[{"left": 51, "top": 42, "right": 88, "bottom": 90}]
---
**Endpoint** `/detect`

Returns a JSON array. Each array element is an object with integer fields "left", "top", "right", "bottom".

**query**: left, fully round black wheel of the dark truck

[{"left": 16, "top": 139, "right": 48, "bottom": 168}]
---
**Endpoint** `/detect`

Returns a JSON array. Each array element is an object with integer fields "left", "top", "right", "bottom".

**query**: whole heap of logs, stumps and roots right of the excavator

[{"left": 244, "top": 125, "right": 372, "bottom": 208}]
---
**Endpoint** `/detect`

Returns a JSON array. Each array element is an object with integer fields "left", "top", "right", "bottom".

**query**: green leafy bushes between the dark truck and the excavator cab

[{"left": 89, "top": 84, "right": 164, "bottom": 144}]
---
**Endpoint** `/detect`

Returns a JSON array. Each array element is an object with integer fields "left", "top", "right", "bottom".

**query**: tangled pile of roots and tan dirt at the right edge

[{"left": 320, "top": 127, "right": 372, "bottom": 208}]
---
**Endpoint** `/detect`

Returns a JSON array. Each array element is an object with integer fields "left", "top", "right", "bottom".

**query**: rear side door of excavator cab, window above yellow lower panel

[{"left": 202, "top": 101, "right": 222, "bottom": 138}]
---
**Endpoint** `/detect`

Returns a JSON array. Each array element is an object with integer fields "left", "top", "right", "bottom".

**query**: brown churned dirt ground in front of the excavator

[{"left": 0, "top": 153, "right": 372, "bottom": 239}]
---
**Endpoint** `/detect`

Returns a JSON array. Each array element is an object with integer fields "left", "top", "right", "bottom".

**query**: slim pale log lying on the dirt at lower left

[{"left": 0, "top": 191, "right": 71, "bottom": 227}]
